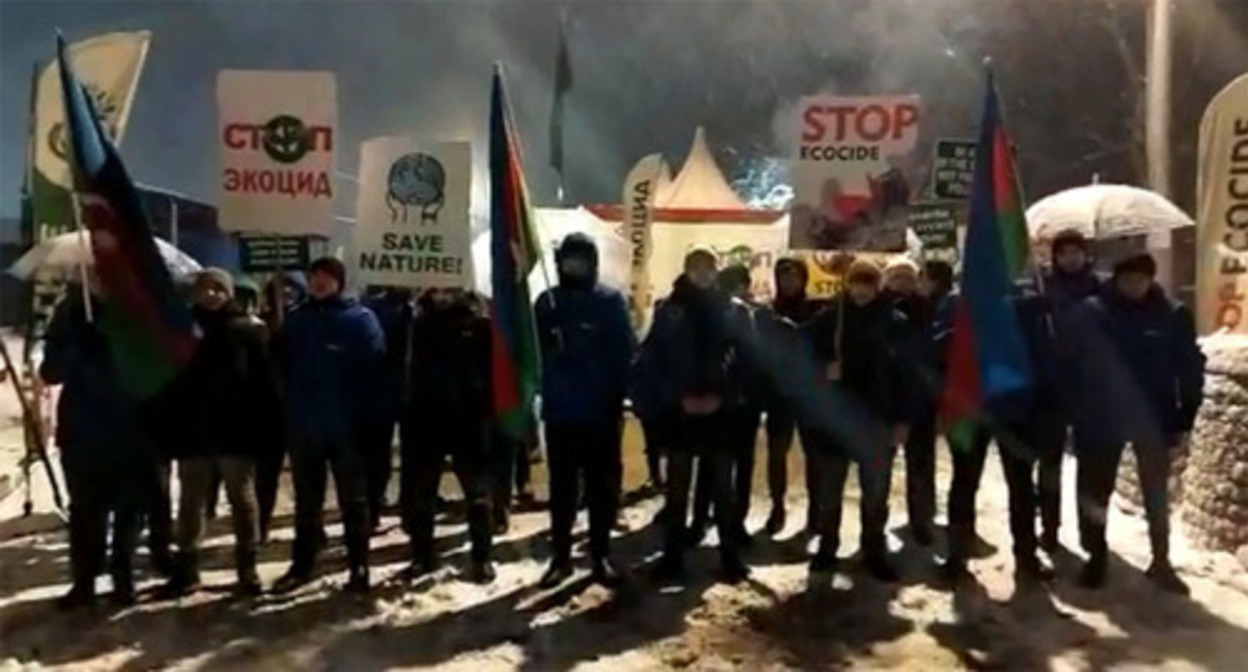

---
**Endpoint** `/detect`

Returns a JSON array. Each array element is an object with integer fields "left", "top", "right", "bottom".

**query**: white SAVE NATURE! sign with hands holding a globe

[{"left": 353, "top": 136, "right": 473, "bottom": 287}]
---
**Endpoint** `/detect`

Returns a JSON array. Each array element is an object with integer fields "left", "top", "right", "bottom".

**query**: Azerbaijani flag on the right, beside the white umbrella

[{"left": 941, "top": 72, "right": 1031, "bottom": 447}]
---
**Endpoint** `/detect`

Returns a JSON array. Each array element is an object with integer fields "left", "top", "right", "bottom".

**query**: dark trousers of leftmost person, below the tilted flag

[{"left": 61, "top": 445, "right": 141, "bottom": 591}]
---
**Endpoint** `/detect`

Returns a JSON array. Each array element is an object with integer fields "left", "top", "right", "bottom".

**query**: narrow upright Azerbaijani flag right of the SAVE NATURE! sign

[{"left": 489, "top": 65, "right": 542, "bottom": 440}]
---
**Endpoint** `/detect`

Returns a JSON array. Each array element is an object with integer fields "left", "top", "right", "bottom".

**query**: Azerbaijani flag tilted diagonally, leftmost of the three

[{"left": 56, "top": 34, "right": 196, "bottom": 400}]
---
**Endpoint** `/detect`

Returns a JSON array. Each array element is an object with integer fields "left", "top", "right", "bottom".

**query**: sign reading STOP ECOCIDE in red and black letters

[{"left": 789, "top": 95, "right": 920, "bottom": 252}]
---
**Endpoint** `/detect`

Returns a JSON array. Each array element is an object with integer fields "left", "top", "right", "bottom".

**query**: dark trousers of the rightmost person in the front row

[{"left": 1076, "top": 441, "right": 1171, "bottom": 562}]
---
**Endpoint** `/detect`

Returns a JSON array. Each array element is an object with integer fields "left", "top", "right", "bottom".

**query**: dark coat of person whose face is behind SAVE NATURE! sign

[{"left": 402, "top": 296, "right": 493, "bottom": 427}]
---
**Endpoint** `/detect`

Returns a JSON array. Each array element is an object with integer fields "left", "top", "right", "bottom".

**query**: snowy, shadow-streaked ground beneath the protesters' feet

[{"left": 0, "top": 414, "right": 1248, "bottom": 672}]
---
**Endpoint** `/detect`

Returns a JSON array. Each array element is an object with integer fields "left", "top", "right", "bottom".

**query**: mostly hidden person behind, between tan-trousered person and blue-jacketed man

[{"left": 256, "top": 271, "right": 308, "bottom": 546}]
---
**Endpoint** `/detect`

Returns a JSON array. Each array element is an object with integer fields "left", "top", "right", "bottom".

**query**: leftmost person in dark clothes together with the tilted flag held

[{"left": 40, "top": 34, "right": 197, "bottom": 607}]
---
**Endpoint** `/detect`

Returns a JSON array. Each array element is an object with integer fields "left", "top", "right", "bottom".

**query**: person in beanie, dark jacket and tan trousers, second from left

[{"left": 147, "top": 267, "right": 280, "bottom": 596}]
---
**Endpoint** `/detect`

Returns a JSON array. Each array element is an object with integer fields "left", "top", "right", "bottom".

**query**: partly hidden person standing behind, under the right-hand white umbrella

[{"left": 1037, "top": 229, "right": 1104, "bottom": 553}]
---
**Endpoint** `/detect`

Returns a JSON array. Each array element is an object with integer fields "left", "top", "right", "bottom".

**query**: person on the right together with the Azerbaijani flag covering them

[{"left": 940, "top": 65, "right": 1056, "bottom": 583}]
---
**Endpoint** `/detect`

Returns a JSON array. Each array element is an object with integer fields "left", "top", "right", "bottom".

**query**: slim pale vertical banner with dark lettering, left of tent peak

[{"left": 620, "top": 154, "right": 663, "bottom": 329}]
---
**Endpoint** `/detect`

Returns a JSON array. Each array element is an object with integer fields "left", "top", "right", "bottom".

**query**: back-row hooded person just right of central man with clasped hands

[{"left": 756, "top": 257, "right": 826, "bottom": 535}]
